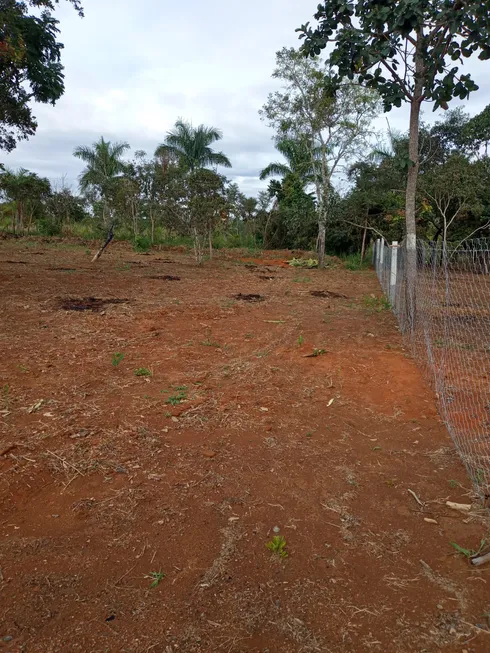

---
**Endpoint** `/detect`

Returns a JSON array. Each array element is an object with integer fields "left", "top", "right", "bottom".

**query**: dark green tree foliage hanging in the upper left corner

[{"left": 0, "top": 0, "right": 83, "bottom": 151}]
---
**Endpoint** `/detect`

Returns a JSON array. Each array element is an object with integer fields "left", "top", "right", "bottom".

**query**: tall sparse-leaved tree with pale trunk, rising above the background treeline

[{"left": 261, "top": 48, "right": 377, "bottom": 267}]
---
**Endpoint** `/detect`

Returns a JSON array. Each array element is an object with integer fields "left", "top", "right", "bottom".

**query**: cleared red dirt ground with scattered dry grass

[{"left": 0, "top": 241, "right": 490, "bottom": 653}]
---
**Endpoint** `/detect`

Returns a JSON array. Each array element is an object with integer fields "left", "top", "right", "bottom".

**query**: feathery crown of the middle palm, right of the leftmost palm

[{"left": 155, "top": 120, "right": 231, "bottom": 172}]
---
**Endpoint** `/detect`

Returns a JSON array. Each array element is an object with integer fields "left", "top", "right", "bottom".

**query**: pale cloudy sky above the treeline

[{"left": 0, "top": 0, "right": 490, "bottom": 195}]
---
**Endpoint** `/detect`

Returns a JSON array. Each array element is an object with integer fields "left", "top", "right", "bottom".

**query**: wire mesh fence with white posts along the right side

[{"left": 373, "top": 239, "right": 490, "bottom": 505}]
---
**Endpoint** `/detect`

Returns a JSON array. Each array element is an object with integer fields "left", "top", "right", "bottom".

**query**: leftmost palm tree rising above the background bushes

[{"left": 73, "top": 136, "right": 129, "bottom": 224}]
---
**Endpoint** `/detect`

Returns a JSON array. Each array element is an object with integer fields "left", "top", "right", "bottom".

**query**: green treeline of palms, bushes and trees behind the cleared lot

[{"left": 0, "top": 49, "right": 490, "bottom": 261}]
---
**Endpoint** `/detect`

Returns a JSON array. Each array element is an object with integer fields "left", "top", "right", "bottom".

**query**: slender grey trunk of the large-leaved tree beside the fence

[{"left": 405, "top": 32, "right": 424, "bottom": 330}]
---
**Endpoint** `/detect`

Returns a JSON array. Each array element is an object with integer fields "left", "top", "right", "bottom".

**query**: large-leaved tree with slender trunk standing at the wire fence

[{"left": 298, "top": 0, "right": 490, "bottom": 310}]
